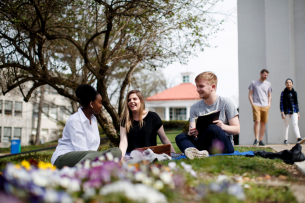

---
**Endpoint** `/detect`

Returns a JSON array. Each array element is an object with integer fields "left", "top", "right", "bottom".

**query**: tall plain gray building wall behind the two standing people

[{"left": 237, "top": 0, "right": 305, "bottom": 144}]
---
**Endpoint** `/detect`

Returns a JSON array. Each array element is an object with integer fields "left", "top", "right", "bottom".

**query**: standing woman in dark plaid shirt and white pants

[{"left": 280, "top": 78, "right": 305, "bottom": 145}]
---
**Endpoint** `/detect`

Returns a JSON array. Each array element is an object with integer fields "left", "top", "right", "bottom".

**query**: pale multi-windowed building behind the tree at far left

[{"left": 0, "top": 86, "right": 72, "bottom": 147}]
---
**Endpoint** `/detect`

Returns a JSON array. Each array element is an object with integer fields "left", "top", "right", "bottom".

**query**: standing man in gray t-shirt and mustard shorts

[{"left": 248, "top": 69, "right": 272, "bottom": 146}]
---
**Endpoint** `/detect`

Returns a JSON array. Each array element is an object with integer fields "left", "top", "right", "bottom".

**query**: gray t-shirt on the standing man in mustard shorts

[{"left": 249, "top": 80, "right": 272, "bottom": 107}]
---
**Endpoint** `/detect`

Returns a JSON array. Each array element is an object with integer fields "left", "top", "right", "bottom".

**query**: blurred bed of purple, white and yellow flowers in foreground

[{"left": 0, "top": 154, "right": 245, "bottom": 203}]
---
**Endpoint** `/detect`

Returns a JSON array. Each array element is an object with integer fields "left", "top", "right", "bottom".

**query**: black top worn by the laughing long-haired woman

[{"left": 121, "top": 111, "right": 163, "bottom": 152}]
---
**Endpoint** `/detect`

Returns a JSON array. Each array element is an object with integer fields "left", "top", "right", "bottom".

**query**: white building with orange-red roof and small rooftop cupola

[{"left": 145, "top": 72, "right": 200, "bottom": 121}]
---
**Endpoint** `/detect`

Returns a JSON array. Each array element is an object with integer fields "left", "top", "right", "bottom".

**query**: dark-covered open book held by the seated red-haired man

[{"left": 195, "top": 110, "right": 220, "bottom": 134}]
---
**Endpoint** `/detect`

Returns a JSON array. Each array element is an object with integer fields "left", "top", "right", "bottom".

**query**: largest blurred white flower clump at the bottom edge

[{"left": 100, "top": 181, "right": 167, "bottom": 203}]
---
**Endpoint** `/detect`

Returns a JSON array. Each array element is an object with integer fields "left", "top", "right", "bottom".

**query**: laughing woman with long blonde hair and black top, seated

[{"left": 119, "top": 90, "right": 175, "bottom": 157}]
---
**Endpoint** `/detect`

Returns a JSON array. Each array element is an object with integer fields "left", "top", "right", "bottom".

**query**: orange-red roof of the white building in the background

[{"left": 146, "top": 83, "right": 200, "bottom": 101}]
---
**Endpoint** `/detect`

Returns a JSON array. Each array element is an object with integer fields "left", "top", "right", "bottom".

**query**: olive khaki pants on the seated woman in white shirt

[{"left": 54, "top": 147, "right": 122, "bottom": 169}]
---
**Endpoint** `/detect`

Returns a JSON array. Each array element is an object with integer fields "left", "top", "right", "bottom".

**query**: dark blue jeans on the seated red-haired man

[{"left": 176, "top": 124, "right": 234, "bottom": 154}]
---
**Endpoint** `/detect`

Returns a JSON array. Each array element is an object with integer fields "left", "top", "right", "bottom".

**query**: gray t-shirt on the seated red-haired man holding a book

[{"left": 190, "top": 96, "right": 238, "bottom": 146}]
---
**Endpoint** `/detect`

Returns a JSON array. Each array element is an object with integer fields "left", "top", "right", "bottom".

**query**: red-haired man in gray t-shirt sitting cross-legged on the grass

[{"left": 176, "top": 72, "right": 240, "bottom": 159}]
